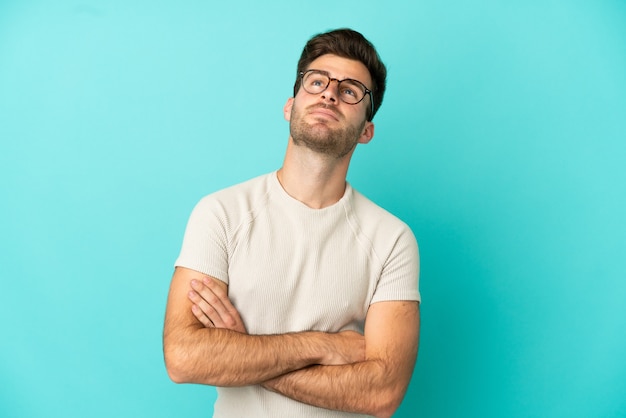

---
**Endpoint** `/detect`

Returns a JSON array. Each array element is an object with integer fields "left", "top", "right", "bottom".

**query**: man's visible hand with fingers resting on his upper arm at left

[{"left": 188, "top": 277, "right": 247, "bottom": 334}]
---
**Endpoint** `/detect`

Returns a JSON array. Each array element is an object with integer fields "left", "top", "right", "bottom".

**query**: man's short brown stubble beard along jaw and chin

[{"left": 289, "top": 107, "right": 365, "bottom": 159}]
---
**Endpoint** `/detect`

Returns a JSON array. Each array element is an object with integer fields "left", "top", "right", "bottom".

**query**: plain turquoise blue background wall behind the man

[{"left": 0, "top": 0, "right": 626, "bottom": 418}]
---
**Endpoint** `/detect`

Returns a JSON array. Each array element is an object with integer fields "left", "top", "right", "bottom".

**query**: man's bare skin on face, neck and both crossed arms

[{"left": 163, "top": 55, "right": 420, "bottom": 417}]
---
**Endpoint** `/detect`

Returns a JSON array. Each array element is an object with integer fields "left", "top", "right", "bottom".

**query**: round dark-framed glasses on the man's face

[{"left": 300, "top": 70, "right": 374, "bottom": 119}]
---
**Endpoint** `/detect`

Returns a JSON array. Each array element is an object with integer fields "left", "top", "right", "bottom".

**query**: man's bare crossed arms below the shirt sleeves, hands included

[{"left": 163, "top": 267, "right": 419, "bottom": 416}]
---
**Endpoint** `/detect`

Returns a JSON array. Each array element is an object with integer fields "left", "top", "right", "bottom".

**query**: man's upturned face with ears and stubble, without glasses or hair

[{"left": 285, "top": 55, "right": 374, "bottom": 159}]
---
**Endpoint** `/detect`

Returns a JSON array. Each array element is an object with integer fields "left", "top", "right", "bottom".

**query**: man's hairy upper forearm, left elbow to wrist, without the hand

[{"left": 164, "top": 327, "right": 327, "bottom": 386}]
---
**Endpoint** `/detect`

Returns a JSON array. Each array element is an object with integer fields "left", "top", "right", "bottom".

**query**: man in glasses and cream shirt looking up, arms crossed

[{"left": 163, "top": 29, "right": 420, "bottom": 417}]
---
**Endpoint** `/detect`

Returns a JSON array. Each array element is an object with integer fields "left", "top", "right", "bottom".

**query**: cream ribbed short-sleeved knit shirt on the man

[{"left": 176, "top": 172, "right": 420, "bottom": 418}]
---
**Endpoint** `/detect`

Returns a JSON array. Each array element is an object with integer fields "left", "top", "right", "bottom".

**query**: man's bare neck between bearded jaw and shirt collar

[{"left": 277, "top": 138, "right": 354, "bottom": 209}]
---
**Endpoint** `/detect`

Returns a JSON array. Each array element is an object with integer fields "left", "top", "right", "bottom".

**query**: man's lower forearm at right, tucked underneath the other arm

[{"left": 263, "top": 360, "right": 406, "bottom": 417}]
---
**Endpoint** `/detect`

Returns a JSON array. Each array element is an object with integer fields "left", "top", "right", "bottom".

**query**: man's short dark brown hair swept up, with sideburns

[{"left": 293, "top": 29, "right": 387, "bottom": 121}]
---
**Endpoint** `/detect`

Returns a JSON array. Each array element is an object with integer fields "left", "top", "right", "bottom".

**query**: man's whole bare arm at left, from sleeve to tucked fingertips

[{"left": 163, "top": 267, "right": 365, "bottom": 386}]
